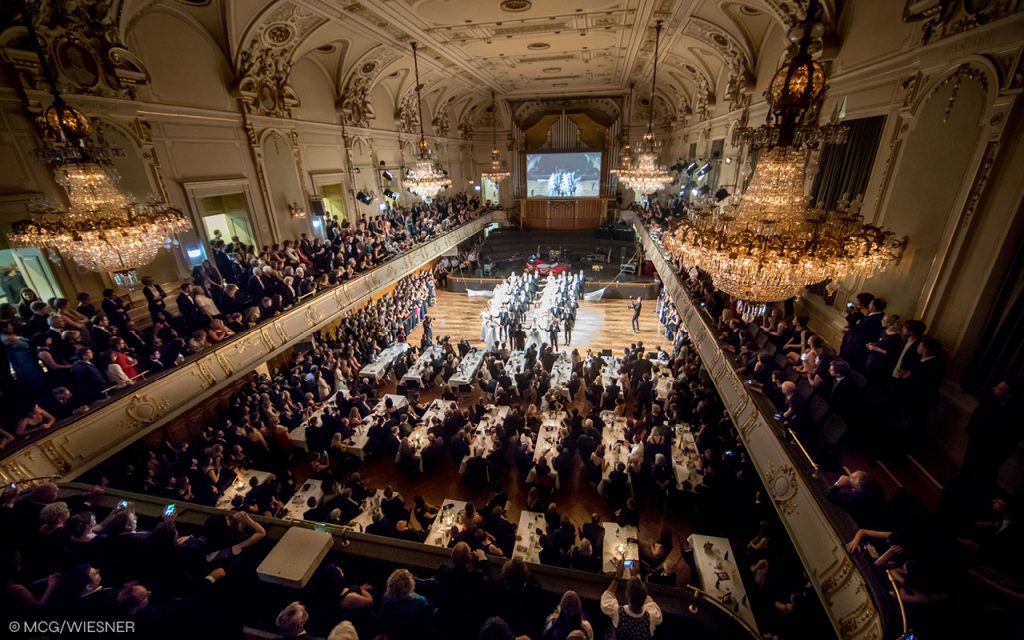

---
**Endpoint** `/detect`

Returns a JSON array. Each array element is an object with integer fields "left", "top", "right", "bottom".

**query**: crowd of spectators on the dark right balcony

[{"left": 637, "top": 200, "right": 1024, "bottom": 637}]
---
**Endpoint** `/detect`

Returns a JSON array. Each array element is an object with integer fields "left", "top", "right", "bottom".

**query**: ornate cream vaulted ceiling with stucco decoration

[{"left": 12, "top": 0, "right": 835, "bottom": 129}]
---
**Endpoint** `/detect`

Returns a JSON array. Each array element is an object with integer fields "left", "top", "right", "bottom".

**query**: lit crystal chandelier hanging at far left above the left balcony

[{"left": 8, "top": 5, "right": 191, "bottom": 286}]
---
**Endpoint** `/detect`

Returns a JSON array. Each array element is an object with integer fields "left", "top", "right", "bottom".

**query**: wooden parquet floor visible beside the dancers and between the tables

[{"left": 331, "top": 291, "right": 692, "bottom": 585}]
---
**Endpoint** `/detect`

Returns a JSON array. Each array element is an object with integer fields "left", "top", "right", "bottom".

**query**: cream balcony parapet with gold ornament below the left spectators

[{"left": 0, "top": 211, "right": 505, "bottom": 483}]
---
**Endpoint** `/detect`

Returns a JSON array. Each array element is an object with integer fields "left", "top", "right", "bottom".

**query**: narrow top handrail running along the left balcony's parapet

[{"left": 0, "top": 207, "right": 502, "bottom": 460}]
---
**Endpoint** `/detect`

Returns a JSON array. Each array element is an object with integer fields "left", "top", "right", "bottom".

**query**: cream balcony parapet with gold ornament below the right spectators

[{"left": 635, "top": 222, "right": 903, "bottom": 640}]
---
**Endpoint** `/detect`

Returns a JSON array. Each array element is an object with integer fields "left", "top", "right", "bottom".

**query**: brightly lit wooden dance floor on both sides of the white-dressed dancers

[{"left": 409, "top": 291, "right": 672, "bottom": 355}]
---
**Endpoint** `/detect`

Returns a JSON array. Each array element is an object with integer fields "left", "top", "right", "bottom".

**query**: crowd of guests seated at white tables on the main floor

[{"left": 75, "top": 276, "right": 820, "bottom": 638}]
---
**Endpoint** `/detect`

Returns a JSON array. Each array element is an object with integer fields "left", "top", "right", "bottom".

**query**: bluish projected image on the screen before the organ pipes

[{"left": 526, "top": 152, "right": 601, "bottom": 198}]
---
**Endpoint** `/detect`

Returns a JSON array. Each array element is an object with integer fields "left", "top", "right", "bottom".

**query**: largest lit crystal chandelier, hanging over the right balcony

[{"left": 666, "top": 0, "right": 906, "bottom": 307}]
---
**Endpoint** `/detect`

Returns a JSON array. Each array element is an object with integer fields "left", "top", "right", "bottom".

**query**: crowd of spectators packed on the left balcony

[{"left": 0, "top": 195, "right": 481, "bottom": 449}]
